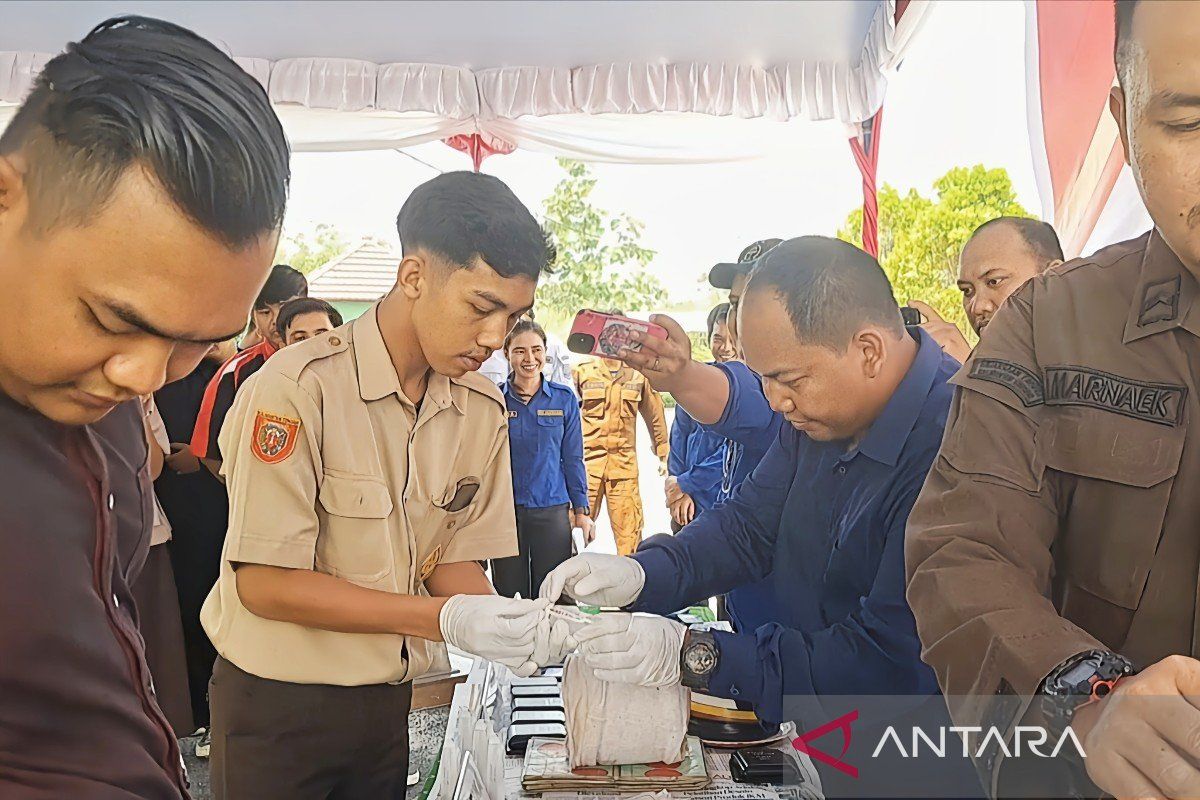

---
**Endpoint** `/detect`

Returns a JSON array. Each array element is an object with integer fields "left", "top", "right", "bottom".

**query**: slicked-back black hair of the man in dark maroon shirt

[{"left": 0, "top": 16, "right": 290, "bottom": 248}]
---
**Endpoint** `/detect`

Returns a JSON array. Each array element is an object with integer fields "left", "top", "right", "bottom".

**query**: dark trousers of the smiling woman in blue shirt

[{"left": 492, "top": 504, "right": 571, "bottom": 599}]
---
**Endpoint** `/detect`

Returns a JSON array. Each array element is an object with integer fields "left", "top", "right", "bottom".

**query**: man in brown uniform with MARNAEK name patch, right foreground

[{"left": 907, "top": 1, "right": 1200, "bottom": 798}]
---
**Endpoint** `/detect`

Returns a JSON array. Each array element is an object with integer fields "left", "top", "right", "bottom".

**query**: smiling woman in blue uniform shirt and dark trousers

[{"left": 492, "top": 319, "right": 594, "bottom": 597}]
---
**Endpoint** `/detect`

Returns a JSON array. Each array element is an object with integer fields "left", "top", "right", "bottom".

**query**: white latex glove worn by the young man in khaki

[{"left": 438, "top": 595, "right": 549, "bottom": 678}]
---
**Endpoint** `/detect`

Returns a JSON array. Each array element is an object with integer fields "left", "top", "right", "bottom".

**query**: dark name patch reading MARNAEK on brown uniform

[{"left": 1045, "top": 365, "right": 1188, "bottom": 426}]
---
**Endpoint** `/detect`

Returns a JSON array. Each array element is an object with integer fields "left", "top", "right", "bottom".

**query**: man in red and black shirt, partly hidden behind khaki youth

[{"left": 192, "top": 264, "right": 308, "bottom": 475}]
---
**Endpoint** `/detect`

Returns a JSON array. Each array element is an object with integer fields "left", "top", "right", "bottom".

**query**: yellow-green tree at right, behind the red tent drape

[{"left": 838, "top": 164, "right": 1033, "bottom": 342}]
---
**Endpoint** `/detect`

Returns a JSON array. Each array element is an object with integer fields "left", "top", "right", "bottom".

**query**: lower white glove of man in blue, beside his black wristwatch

[{"left": 574, "top": 614, "right": 688, "bottom": 686}]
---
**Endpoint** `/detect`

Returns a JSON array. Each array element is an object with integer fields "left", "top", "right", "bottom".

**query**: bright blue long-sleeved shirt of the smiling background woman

[{"left": 500, "top": 379, "right": 588, "bottom": 509}]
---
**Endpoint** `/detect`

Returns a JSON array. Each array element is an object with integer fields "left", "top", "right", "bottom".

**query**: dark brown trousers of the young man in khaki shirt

[{"left": 209, "top": 658, "right": 413, "bottom": 800}]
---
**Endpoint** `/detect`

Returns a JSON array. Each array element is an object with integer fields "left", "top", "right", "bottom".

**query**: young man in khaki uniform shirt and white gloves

[{"left": 202, "top": 173, "right": 565, "bottom": 800}]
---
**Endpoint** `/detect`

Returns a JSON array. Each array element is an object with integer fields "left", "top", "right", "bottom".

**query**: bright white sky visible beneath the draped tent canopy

[{"left": 284, "top": 0, "right": 1040, "bottom": 302}]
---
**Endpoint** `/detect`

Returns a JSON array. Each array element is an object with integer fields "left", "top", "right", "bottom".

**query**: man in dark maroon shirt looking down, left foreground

[{"left": 0, "top": 17, "right": 289, "bottom": 800}]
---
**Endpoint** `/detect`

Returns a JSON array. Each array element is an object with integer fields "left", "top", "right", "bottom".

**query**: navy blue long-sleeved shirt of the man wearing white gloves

[{"left": 631, "top": 331, "right": 959, "bottom": 722}]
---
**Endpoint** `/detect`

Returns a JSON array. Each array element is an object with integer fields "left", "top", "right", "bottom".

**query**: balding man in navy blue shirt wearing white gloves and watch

[{"left": 542, "top": 236, "right": 958, "bottom": 722}]
